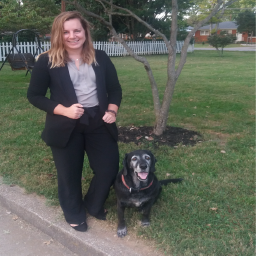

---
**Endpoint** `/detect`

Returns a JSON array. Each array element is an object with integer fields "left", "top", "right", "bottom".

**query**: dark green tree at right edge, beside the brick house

[{"left": 236, "top": 10, "right": 256, "bottom": 35}]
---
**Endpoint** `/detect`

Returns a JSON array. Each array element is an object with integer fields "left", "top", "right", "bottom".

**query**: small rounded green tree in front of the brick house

[{"left": 207, "top": 31, "right": 236, "bottom": 55}]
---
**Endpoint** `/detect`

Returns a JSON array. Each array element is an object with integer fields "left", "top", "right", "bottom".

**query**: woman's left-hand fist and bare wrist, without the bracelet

[{"left": 53, "top": 103, "right": 84, "bottom": 119}]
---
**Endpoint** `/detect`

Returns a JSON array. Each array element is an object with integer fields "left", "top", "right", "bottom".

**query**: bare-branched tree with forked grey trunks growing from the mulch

[{"left": 65, "top": 0, "right": 236, "bottom": 135}]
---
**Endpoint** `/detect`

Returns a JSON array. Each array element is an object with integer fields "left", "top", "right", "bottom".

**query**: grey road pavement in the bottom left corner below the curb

[{"left": 0, "top": 205, "right": 77, "bottom": 256}]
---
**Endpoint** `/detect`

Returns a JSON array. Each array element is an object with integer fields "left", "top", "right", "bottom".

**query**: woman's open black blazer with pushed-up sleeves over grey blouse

[{"left": 27, "top": 50, "right": 122, "bottom": 147}]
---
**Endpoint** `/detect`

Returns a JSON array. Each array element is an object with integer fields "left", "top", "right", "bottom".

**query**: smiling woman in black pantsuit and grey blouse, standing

[{"left": 27, "top": 12, "right": 122, "bottom": 231}]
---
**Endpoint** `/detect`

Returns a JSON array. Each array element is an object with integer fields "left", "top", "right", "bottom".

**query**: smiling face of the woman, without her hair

[{"left": 63, "top": 19, "right": 86, "bottom": 53}]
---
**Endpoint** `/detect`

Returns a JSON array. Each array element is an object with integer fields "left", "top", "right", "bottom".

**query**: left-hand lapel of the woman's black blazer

[{"left": 58, "top": 64, "right": 78, "bottom": 104}]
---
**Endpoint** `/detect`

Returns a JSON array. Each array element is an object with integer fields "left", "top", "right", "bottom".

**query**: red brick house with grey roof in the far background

[{"left": 195, "top": 21, "right": 256, "bottom": 43}]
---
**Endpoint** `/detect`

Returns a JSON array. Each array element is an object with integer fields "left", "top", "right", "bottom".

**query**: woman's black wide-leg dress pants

[{"left": 51, "top": 111, "right": 119, "bottom": 224}]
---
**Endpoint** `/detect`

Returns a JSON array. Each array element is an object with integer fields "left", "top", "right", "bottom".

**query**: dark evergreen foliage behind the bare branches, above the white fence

[{"left": 66, "top": 0, "right": 192, "bottom": 41}]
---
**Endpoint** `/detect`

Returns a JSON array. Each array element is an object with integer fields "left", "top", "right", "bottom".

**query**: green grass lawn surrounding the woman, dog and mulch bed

[{"left": 0, "top": 51, "right": 255, "bottom": 256}]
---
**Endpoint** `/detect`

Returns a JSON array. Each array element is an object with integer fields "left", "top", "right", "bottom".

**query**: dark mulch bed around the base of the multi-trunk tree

[{"left": 118, "top": 126, "right": 202, "bottom": 147}]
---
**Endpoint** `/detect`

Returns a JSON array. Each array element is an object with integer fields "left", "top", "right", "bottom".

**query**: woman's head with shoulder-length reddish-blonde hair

[{"left": 48, "top": 12, "right": 96, "bottom": 68}]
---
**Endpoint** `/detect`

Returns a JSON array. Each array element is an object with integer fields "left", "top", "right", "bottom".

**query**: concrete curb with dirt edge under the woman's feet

[{"left": 0, "top": 177, "right": 163, "bottom": 256}]
